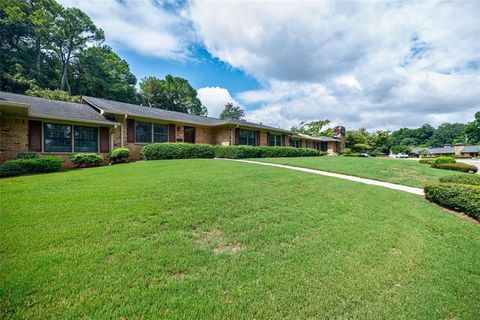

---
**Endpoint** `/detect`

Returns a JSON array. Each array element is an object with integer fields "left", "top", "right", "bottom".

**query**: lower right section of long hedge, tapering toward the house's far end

[{"left": 215, "top": 146, "right": 327, "bottom": 159}]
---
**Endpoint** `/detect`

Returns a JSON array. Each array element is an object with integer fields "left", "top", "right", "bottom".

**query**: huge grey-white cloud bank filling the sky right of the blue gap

[{"left": 190, "top": 1, "right": 480, "bottom": 129}]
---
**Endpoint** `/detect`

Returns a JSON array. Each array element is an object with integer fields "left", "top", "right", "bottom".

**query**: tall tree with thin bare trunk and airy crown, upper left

[{"left": 52, "top": 8, "right": 105, "bottom": 93}]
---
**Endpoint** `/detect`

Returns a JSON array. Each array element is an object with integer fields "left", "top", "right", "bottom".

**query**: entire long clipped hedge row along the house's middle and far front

[{"left": 142, "top": 142, "right": 326, "bottom": 160}]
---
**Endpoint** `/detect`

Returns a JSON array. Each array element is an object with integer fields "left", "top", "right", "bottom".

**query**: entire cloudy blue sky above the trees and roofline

[{"left": 60, "top": 0, "right": 480, "bottom": 130}]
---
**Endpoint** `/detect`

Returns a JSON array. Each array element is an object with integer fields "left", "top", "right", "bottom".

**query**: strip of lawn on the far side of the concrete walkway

[{"left": 252, "top": 157, "right": 466, "bottom": 188}]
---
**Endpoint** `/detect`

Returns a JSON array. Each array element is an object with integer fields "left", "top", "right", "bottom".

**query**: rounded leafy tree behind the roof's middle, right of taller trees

[{"left": 140, "top": 75, "right": 207, "bottom": 116}]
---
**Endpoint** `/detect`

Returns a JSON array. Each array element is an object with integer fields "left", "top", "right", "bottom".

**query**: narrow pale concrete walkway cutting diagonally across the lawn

[{"left": 220, "top": 158, "right": 424, "bottom": 196}]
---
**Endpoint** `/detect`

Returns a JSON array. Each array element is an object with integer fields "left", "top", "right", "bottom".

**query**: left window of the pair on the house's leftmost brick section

[{"left": 44, "top": 123, "right": 72, "bottom": 152}]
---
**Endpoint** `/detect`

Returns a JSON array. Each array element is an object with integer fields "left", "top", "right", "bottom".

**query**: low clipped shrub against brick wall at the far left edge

[{"left": 0, "top": 156, "right": 63, "bottom": 177}]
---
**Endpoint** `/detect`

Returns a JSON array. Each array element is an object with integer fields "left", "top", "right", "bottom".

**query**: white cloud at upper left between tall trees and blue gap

[{"left": 59, "top": 0, "right": 193, "bottom": 60}]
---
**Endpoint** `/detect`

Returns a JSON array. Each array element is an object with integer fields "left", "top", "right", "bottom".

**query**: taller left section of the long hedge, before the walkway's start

[{"left": 142, "top": 142, "right": 215, "bottom": 160}]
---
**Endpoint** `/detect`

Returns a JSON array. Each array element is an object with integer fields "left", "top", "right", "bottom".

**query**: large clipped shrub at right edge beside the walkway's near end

[{"left": 424, "top": 183, "right": 480, "bottom": 220}]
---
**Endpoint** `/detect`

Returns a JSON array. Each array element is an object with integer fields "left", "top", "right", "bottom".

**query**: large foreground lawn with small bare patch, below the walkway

[{"left": 0, "top": 160, "right": 480, "bottom": 319}]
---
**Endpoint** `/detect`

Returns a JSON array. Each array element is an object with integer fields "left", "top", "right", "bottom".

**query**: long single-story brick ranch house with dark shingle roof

[{"left": 0, "top": 92, "right": 345, "bottom": 166}]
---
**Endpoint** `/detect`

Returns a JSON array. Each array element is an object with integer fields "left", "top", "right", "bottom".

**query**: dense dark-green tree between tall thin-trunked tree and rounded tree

[{"left": 72, "top": 46, "right": 137, "bottom": 103}]
